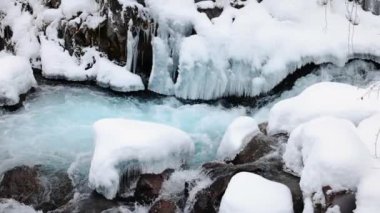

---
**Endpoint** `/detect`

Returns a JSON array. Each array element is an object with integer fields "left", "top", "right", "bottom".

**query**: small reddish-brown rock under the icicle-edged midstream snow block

[{"left": 134, "top": 174, "right": 165, "bottom": 203}]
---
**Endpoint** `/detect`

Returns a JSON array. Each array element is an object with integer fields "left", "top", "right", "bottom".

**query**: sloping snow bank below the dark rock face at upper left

[{"left": 41, "top": 37, "right": 145, "bottom": 92}]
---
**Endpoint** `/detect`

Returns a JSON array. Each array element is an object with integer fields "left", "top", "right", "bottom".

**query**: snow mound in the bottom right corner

[{"left": 355, "top": 170, "right": 380, "bottom": 213}]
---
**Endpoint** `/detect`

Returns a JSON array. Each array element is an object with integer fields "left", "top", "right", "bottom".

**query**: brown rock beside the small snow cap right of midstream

[{"left": 231, "top": 134, "right": 276, "bottom": 165}]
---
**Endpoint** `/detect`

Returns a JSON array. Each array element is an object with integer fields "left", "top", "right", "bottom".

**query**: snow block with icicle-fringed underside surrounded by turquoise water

[{"left": 89, "top": 119, "right": 194, "bottom": 199}]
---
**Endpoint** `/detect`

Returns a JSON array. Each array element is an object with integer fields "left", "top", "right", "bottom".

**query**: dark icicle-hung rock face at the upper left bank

[{"left": 59, "top": 0, "right": 152, "bottom": 80}]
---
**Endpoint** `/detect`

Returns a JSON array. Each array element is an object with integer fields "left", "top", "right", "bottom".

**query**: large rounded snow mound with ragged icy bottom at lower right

[{"left": 283, "top": 117, "right": 371, "bottom": 208}]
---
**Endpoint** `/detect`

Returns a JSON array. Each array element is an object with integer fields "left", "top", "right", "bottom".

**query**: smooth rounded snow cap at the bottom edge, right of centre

[{"left": 219, "top": 172, "right": 293, "bottom": 213}]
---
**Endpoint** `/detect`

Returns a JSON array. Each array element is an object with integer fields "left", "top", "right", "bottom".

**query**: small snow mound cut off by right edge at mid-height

[{"left": 358, "top": 114, "right": 380, "bottom": 157}]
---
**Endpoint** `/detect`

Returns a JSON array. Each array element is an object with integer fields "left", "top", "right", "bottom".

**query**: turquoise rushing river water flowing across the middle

[{"left": 0, "top": 86, "right": 246, "bottom": 176}]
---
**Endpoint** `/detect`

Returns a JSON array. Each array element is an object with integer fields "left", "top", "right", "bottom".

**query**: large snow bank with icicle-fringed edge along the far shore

[{"left": 147, "top": 0, "right": 380, "bottom": 100}]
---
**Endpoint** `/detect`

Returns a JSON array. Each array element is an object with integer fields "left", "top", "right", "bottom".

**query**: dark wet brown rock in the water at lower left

[{"left": 0, "top": 166, "right": 73, "bottom": 211}]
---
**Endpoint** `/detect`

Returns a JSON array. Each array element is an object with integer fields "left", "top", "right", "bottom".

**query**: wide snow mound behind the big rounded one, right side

[{"left": 268, "top": 82, "right": 380, "bottom": 134}]
